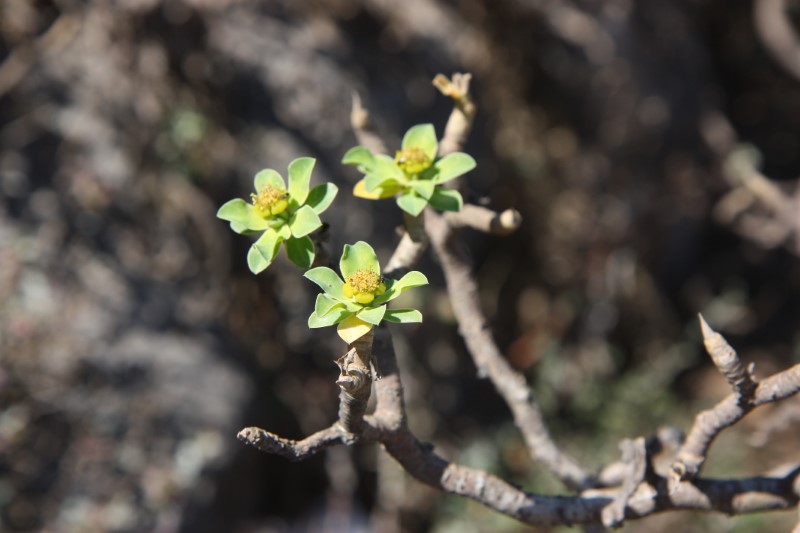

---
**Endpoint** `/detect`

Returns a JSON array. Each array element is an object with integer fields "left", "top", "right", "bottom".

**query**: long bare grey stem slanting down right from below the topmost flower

[{"left": 426, "top": 211, "right": 592, "bottom": 489}]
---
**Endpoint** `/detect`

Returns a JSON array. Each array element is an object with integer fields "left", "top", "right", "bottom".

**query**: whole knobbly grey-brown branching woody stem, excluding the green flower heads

[{"left": 238, "top": 72, "right": 800, "bottom": 527}]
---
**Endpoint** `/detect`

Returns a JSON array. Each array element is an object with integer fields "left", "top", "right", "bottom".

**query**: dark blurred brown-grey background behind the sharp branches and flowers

[{"left": 0, "top": 0, "right": 800, "bottom": 533}]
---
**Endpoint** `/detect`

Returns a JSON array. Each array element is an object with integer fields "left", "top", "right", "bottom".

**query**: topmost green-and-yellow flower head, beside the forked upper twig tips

[{"left": 342, "top": 124, "right": 475, "bottom": 216}]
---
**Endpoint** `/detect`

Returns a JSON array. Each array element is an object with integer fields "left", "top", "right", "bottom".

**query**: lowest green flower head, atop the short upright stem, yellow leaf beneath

[{"left": 305, "top": 241, "right": 428, "bottom": 344}]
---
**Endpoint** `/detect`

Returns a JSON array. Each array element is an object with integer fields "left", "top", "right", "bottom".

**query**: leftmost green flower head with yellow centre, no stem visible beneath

[{"left": 217, "top": 157, "right": 339, "bottom": 274}]
